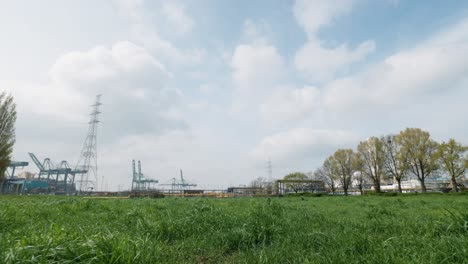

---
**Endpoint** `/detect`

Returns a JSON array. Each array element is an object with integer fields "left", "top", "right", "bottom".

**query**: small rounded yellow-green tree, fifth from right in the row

[{"left": 326, "top": 149, "right": 360, "bottom": 195}]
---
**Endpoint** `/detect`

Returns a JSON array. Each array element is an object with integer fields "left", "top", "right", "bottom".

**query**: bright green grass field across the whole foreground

[{"left": 0, "top": 195, "right": 468, "bottom": 263}]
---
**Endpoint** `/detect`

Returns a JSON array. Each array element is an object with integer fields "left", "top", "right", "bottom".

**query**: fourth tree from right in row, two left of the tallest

[{"left": 358, "top": 137, "right": 385, "bottom": 193}]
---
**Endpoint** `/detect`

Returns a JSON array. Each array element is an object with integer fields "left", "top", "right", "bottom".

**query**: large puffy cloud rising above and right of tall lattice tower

[{"left": 51, "top": 42, "right": 184, "bottom": 137}]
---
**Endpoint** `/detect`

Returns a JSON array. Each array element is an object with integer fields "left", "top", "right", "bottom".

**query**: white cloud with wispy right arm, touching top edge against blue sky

[{"left": 293, "top": 0, "right": 376, "bottom": 82}]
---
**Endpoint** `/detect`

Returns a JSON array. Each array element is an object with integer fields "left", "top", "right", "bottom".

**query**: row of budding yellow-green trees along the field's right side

[{"left": 313, "top": 128, "right": 468, "bottom": 195}]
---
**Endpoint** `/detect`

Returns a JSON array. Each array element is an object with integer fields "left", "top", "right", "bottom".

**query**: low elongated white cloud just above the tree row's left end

[{"left": 251, "top": 127, "right": 357, "bottom": 160}]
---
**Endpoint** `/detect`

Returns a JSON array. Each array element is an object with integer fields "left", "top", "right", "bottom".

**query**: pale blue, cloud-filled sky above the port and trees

[{"left": 0, "top": 0, "right": 468, "bottom": 190}]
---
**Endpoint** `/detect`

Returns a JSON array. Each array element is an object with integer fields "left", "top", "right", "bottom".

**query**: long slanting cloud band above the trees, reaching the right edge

[{"left": 323, "top": 19, "right": 468, "bottom": 111}]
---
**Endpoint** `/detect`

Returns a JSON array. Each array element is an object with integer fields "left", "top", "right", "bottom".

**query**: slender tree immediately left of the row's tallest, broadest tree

[{"left": 381, "top": 135, "right": 408, "bottom": 193}]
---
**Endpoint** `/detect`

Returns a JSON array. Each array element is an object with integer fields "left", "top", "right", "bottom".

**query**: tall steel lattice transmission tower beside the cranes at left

[{"left": 76, "top": 94, "right": 102, "bottom": 192}]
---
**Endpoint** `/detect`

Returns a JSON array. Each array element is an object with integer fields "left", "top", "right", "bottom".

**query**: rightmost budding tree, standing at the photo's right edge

[{"left": 437, "top": 139, "right": 468, "bottom": 192}]
